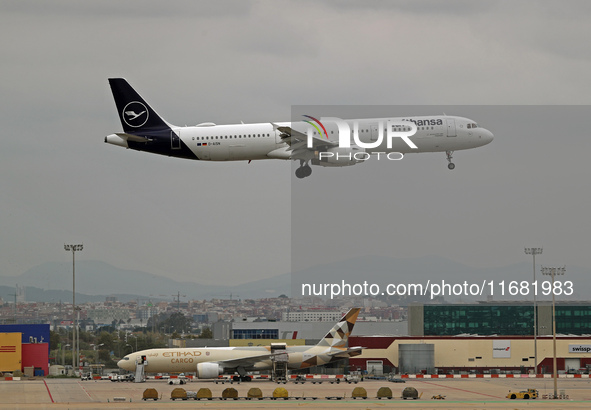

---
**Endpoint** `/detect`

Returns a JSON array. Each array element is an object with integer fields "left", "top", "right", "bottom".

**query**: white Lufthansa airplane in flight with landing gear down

[{"left": 105, "top": 78, "right": 493, "bottom": 178}]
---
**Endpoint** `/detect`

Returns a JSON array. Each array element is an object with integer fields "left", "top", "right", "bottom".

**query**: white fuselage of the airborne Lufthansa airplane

[{"left": 105, "top": 116, "right": 492, "bottom": 161}]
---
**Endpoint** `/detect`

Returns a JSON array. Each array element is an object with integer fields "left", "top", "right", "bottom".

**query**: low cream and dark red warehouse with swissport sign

[{"left": 349, "top": 335, "right": 591, "bottom": 374}]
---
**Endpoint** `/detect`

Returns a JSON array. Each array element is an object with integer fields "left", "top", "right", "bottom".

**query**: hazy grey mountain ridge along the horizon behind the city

[{"left": 0, "top": 256, "right": 591, "bottom": 302}]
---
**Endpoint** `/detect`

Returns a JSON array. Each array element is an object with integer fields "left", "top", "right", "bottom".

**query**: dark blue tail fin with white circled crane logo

[{"left": 109, "top": 78, "right": 172, "bottom": 134}]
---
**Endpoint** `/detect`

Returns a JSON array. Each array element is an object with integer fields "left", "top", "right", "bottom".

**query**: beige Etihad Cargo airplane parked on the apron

[{"left": 117, "top": 308, "right": 363, "bottom": 381}]
